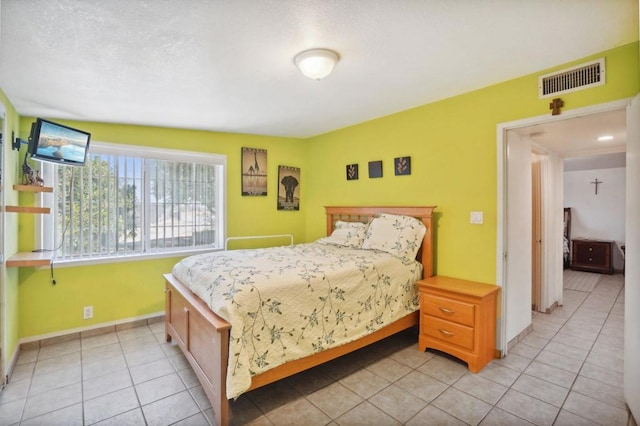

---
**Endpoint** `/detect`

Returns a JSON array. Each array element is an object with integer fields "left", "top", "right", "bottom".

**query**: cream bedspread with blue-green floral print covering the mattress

[{"left": 173, "top": 243, "right": 422, "bottom": 398}]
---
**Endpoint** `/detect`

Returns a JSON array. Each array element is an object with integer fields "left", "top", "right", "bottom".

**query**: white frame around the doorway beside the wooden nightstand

[{"left": 496, "top": 98, "right": 631, "bottom": 356}]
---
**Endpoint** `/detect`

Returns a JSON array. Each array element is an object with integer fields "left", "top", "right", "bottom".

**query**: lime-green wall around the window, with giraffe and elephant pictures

[{"left": 13, "top": 118, "right": 307, "bottom": 338}]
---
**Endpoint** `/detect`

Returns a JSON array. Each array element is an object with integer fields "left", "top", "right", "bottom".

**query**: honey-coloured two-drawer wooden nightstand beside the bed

[{"left": 418, "top": 276, "right": 500, "bottom": 373}]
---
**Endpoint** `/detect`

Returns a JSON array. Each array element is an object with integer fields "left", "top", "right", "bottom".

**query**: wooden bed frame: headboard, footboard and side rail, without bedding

[{"left": 163, "top": 206, "right": 435, "bottom": 425}]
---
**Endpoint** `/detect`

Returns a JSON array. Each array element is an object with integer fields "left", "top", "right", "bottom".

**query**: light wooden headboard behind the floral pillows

[{"left": 325, "top": 206, "right": 436, "bottom": 278}]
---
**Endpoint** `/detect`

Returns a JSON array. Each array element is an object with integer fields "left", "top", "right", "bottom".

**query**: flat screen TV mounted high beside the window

[{"left": 29, "top": 118, "right": 91, "bottom": 166}]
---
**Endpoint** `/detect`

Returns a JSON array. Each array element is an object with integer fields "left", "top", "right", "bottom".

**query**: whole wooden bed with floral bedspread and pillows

[{"left": 164, "top": 206, "right": 435, "bottom": 425}]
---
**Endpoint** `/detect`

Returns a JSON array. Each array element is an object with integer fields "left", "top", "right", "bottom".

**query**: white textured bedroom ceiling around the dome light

[{"left": 0, "top": 0, "right": 638, "bottom": 137}]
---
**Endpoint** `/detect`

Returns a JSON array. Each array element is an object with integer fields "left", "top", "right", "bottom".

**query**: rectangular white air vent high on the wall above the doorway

[{"left": 538, "top": 58, "right": 605, "bottom": 98}]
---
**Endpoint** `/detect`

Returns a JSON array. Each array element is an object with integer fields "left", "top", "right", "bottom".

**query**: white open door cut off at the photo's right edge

[{"left": 624, "top": 95, "right": 640, "bottom": 421}]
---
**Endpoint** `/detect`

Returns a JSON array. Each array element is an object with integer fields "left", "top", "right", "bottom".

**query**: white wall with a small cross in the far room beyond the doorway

[{"left": 564, "top": 167, "right": 626, "bottom": 270}]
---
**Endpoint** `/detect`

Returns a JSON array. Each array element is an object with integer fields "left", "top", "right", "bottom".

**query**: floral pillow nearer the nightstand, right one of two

[{"left": 362, "top": 213, "right": 427, "bottom": 262}]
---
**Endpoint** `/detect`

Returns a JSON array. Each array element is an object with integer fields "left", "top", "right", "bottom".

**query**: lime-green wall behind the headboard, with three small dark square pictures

[{"left": 307, "top": 43, "right": 640, "bottom": 283}]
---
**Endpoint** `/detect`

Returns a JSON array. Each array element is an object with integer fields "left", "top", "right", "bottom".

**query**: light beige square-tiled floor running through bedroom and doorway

[{"left": 0, "top": 275, "right": 630, "bottom": 426}]
